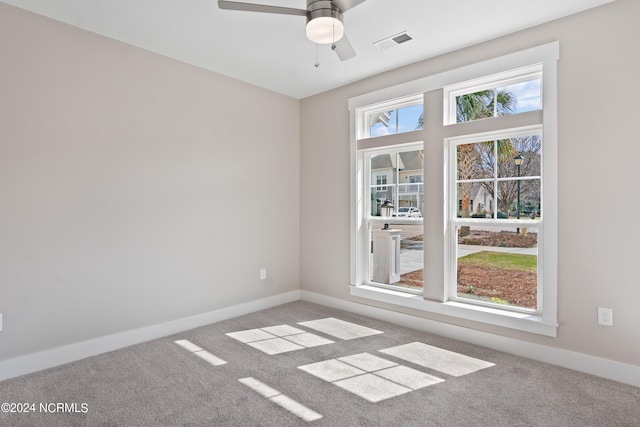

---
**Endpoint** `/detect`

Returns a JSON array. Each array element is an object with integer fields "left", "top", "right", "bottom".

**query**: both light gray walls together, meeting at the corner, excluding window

[{"left": 0, "top": 0, "right": 640, "bottom": 372}]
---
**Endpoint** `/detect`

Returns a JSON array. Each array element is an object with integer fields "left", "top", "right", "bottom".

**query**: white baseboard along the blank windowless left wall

[{"left": 0, "top": 290, "right": 300, "bottom": 381}]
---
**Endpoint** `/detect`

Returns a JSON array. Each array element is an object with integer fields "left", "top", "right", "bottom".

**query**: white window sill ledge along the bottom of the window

[{"left": 349, "top": 285, "right": 558, "bottom": 337}]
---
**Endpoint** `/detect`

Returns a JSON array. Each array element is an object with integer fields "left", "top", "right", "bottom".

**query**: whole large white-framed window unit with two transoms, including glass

[{"left": 349, "top": 42, "right": 559, "bottom": 336}]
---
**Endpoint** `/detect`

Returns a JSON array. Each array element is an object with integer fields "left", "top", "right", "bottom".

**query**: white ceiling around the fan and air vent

[{"left": 0, "top": 0, "right": 614, "bottom": 98}]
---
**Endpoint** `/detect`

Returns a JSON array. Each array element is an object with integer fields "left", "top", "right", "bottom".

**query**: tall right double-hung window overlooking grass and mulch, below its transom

[{"left": 449, "top": 128, "right": 542, "bottom": 312}]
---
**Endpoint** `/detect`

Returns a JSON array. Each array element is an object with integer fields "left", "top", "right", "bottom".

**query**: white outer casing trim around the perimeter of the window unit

[{"left": 348, "top": 41, "right": 560, "bottom": 337}]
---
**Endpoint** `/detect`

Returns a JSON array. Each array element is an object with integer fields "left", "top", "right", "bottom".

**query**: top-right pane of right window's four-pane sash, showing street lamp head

[{"left": 498, "top": 135, "right": 542, "bottom": 178}]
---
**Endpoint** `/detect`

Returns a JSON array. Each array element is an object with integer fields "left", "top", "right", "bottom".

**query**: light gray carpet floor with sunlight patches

[{"left": 0, "top": 302, "right": 640, "bottom": 427}]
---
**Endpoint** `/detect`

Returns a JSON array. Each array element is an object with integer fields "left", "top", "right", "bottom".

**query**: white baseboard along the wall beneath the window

[{"left": 300, "top": 291, "right": 640, "bottom": 387}]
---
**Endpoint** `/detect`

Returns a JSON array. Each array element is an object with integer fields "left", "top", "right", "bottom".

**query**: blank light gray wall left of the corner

[{"left": 0, "top": 4, "right": 300, "bottom": 360}]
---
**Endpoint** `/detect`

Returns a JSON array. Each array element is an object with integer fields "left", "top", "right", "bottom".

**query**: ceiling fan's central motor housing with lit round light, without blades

[{"left": 307, "top": 0, "right": 344, "bottom": 43}]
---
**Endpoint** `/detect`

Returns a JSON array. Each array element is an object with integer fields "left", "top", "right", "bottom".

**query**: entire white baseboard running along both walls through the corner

[{"left": 0, "top": 291, "right": 640, "bottom": 387}]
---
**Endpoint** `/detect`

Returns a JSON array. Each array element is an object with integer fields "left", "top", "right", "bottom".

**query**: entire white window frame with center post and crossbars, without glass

[{"left": 349, "top": 41, "right": 560, "bottom": 337}]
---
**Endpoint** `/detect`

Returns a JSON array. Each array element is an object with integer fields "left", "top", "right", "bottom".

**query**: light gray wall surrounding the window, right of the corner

[{"left": 300, "top": 0, "right": 640, "bottom": 365}]
